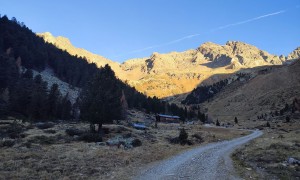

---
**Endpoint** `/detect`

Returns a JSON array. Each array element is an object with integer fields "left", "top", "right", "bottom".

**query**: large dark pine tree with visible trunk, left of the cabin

[{"left": 80, "top": 65, "right": 122, "bottom": 131}]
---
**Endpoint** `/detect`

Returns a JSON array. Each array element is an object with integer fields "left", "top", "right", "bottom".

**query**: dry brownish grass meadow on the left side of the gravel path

[{"left": 0, "top": 119, "right": 245, "bottom": 179}]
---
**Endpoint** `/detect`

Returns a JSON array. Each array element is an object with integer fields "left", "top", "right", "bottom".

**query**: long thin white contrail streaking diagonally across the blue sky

[{"left": 115, "top": 9, "right": 286, "bottom": 58}]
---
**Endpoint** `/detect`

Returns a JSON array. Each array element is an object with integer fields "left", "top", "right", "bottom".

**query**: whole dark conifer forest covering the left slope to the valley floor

[{"left": 0, "top": 16, "right": 184, "bottom": 126}]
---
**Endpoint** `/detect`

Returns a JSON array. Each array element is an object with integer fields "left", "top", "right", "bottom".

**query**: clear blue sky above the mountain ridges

[{"left": 0, "top": 0, "right": 300, "bottom": 62}]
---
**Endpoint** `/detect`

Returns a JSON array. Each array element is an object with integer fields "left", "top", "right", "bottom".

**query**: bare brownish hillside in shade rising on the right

[{"left": 202, "top": 60, "right": 300, "bottom": 125}]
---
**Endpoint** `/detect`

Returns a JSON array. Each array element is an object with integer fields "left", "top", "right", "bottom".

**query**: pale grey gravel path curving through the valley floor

[{"left": 135, "top": 131, "right": 263, "bottom": 180}]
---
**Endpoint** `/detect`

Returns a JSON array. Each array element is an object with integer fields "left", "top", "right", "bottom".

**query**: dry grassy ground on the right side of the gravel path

[{"left": 233, "top": 121, "right": 300, "bottom": 179}]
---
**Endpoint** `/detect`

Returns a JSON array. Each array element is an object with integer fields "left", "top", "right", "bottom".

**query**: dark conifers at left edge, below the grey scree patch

[{"left": 0, "top": 54, "right": 72, "bottom": 120}]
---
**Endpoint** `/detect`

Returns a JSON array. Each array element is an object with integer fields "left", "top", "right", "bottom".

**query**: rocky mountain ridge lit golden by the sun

[{"left": 38, "top": 33, "right": 300, "bottom": 98}]
